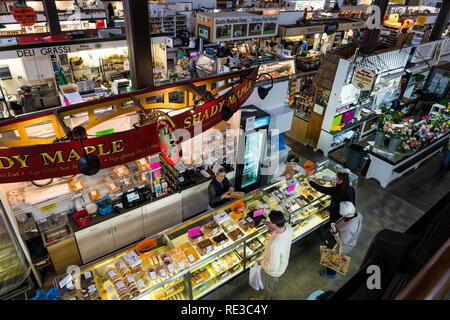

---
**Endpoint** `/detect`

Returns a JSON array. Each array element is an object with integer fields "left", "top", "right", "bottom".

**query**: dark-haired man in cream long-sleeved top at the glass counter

[{"left": 251, "top": 210, "right": 294, "bottom": 300}]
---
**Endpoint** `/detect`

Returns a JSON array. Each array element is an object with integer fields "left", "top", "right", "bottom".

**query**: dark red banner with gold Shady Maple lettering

[{"left": 0, "top": 69, "right": 257, "bottom": 183}]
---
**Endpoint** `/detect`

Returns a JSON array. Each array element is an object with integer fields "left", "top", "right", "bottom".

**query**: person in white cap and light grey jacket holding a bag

[{"left": 320, "top": 201, "right": 363, "bottom": 279}]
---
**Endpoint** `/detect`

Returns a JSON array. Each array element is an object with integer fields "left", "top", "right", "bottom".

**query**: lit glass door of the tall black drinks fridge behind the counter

[{"left": 241, "top": 131, "right": 264, "bottom": 188}]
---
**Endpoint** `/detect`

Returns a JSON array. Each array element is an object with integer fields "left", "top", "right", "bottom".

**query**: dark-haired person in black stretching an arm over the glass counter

[{"left": 309, "top": 172, "right": 355, "bottom": 223}]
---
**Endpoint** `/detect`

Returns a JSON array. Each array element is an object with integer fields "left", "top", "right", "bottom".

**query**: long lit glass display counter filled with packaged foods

[{"left": 54, "top": 160, "right": 357, "bottom": 300}]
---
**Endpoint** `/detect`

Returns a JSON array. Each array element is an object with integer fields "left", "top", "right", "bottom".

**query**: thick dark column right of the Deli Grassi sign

[{"left": 123, "top": 0, "right": 153, "bottom": 90}]
